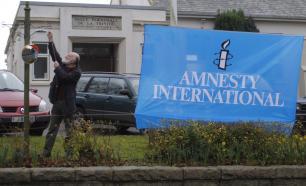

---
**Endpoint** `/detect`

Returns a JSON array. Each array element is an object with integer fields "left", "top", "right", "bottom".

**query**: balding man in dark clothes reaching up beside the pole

[{"left": 43, "top": 32, "right": 81, "bottom": 157}]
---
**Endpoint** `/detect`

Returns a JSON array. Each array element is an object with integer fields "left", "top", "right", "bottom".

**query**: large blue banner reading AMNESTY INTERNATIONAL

[{"left": 136, "top": 25, "right": 304, "bottom": 128}]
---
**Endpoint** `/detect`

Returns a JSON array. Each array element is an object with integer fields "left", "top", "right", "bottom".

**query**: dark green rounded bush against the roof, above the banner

[{"left": 215, "top": 10, "right": 259, "bottom": 32}]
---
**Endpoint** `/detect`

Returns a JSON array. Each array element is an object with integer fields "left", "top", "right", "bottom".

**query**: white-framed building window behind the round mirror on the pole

[{"left": 31, "top": 42, "right": 50, "bottom": 81}]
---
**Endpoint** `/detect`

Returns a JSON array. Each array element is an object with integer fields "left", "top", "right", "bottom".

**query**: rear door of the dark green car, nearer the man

[{"left": 84, "top": 77, "right": 109, "bottom": 120}]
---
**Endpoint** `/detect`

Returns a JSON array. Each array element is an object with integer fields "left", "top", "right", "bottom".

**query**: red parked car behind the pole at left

[{"left": 0, "top": 70, "right": 50, "bottom": 135}]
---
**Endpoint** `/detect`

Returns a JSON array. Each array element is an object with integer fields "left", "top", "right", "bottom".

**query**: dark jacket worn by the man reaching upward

[{"left": 48, "top": 42, "right": 81, "bottom": 116}]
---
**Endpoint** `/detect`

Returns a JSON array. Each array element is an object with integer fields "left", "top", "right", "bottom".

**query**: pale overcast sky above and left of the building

[{"left": 0, "top": 0, "right": 110, "bottom": 69}]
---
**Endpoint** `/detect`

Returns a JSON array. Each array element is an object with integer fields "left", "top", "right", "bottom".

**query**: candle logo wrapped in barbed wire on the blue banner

[{"left": 214, "top": 39, "right": 234, "bottom": 70}]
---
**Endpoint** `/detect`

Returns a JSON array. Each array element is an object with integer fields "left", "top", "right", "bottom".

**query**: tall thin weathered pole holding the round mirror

[{"left": 24, "top": 1, "right": 31, "bottom": 162}]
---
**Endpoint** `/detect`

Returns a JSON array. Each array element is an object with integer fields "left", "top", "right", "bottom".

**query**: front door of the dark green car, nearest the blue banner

[{"left": 104, "top": 77, "right": 134, "bottom": 123}]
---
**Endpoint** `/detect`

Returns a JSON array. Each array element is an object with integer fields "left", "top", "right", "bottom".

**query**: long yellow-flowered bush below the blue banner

[{"left": 146, "top": 123, "right": 306, "bottom": 165}]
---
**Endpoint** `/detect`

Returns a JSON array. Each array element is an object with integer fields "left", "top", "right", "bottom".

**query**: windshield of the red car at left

[{"left": 0, "top": 72, "right": 24, "bottom": 91}]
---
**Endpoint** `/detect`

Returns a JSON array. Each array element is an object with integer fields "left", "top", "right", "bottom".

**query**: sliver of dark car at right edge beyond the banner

[{"left": 294, "top": 97, "right": 306, "bottom": 135}]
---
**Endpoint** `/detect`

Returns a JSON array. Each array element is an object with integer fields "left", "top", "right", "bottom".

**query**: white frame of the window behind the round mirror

[{"left": 31, "top": 41, "right": 50, "bottom": 82}]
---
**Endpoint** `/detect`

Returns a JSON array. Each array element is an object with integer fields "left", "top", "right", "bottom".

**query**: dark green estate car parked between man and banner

[{"left": 77, "top": 72, "right": 139, "bottom": 132}]
